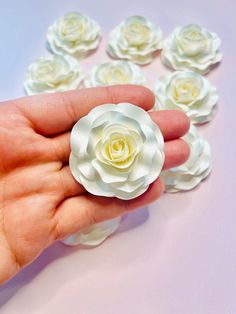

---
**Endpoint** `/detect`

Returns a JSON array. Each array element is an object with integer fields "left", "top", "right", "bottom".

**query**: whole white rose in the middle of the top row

[{"left": 107, "top": 16, "right": 162, "bottom": 64}]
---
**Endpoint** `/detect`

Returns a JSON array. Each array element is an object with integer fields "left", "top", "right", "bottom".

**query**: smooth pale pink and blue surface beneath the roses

[{"left": 0, "top": 0, "right": 236, "bottom": 314}]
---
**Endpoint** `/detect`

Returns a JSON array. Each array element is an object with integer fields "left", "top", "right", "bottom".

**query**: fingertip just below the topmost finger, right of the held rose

[{"left": 150, "top": 110, "right": 190, "bottom": 141}]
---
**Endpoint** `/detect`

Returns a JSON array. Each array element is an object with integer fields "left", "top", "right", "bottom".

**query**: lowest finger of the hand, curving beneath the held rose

[{"left": 54, "top": 179, "right": 164, "bottom": 239}]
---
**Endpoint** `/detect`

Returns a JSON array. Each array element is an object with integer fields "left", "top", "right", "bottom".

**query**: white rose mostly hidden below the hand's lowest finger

[{"left": 62, "top": 217, "right": 121, "bottom": 246}]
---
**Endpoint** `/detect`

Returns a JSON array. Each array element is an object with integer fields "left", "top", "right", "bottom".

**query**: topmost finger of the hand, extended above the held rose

[{"left": 14, "top": 85, "right": 155, "bottom": 136}]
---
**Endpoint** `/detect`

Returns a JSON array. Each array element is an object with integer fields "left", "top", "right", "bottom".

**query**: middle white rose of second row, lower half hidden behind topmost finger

[{"left": 84, "top": 61, "right": 146, "bottom": 87}]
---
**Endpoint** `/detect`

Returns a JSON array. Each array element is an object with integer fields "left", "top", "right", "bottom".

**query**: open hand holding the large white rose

[{"left": 0, "top": 85, "right": 189, "bottom": 284}]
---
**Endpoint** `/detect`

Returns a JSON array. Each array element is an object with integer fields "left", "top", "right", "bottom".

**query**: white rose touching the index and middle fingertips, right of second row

[{"left": 154, "top": 70, "right": 218, "bottom": 123}]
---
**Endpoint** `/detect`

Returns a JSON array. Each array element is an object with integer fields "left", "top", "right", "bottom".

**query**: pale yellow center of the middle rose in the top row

[{"left": 123, "top": 22, "right": 150, "bottom": 46}]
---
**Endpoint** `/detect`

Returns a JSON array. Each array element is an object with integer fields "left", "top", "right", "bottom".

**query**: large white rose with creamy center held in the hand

[{"left": 69, "top": 103, "right": 164, "bottom": 199}]
